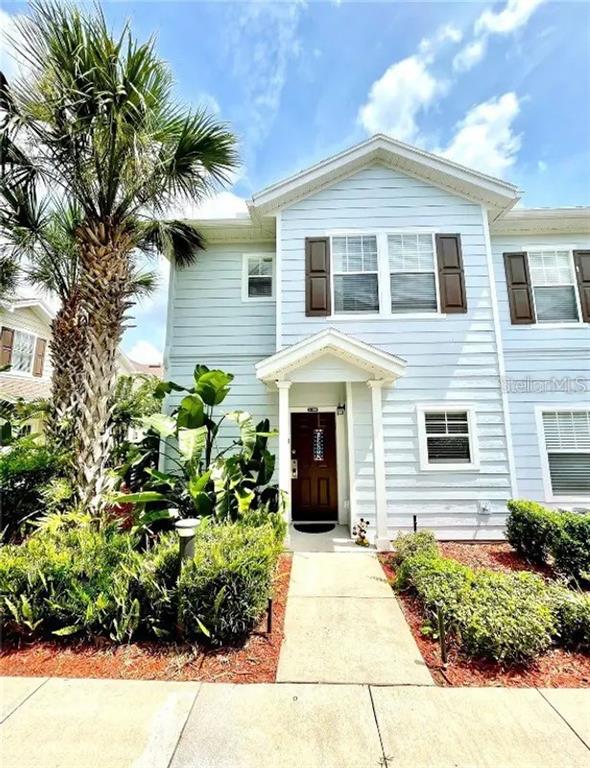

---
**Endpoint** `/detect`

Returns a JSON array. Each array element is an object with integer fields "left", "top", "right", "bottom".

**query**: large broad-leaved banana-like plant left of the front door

[{"left": 112, "top": 365, "right": 282, "bottom": 520}]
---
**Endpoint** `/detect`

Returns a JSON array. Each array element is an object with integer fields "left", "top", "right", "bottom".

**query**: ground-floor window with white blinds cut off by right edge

[{"left": 543, "top": 411, "right": 590, "bottom": 497}]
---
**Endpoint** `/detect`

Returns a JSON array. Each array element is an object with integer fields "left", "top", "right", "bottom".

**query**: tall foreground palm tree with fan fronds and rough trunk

[{"left": 2, "top": 2, "right": 237, "bottom": 506}]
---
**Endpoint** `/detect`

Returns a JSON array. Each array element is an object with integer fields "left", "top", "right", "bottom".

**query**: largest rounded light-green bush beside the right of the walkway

[{"left": 396, "top": 554, "right": 555, "bottom": 662}]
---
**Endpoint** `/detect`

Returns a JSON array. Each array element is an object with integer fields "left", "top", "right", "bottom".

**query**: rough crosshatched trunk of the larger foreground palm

[{"left": 76, "top": 222, "right": 132, "bottom": 510}]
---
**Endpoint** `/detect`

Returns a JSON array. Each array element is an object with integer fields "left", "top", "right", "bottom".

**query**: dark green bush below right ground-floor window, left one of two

[{"left": 506, "top": 499, "right": 560, "bottom": 563}]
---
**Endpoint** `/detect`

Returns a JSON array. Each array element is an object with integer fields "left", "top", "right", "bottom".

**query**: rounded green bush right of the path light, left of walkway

[{"left": 178, "top": 515, "right": 284, "bottom": 644}]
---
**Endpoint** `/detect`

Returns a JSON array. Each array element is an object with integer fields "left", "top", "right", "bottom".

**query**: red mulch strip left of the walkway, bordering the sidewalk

[{"left": 0, "top": 554, "right": 291, "bottom": 683}]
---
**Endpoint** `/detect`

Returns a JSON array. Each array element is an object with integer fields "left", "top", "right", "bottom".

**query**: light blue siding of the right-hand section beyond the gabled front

[{"left": 492, "top": 234, "right": 590, "bottom": 506}]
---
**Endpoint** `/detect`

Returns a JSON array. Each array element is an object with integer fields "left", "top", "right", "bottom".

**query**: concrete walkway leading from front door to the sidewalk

[{"left": 277, "top": 547, "right": 434, "bottom": 685}]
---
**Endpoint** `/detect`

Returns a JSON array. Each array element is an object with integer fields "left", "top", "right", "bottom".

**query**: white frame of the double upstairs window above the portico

[{"left": 326, "top": 227, "right": 447, "bottom": 322}]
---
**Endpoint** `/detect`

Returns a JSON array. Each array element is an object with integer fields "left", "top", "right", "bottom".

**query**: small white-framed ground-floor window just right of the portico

[{"left": 418, "top": 407, "right": 479, "bottom": 469}]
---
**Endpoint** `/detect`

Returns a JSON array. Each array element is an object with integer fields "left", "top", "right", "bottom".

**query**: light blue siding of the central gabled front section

[{"left": 280, "top": 166, "right": 510, "bottom": 538}]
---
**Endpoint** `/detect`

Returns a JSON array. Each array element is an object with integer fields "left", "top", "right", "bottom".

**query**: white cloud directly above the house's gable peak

[{"left": 358, "top": 55, "right": 447, "bottom": 141}]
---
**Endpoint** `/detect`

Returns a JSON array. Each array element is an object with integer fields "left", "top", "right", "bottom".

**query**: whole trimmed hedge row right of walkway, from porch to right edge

[{"left": 395, "top": 534, "right": 590, "bottom": 663}]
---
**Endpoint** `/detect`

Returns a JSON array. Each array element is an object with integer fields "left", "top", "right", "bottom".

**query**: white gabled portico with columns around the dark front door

[{"left": 256, "top": 328, "right": 406, "bottom": 548}]
